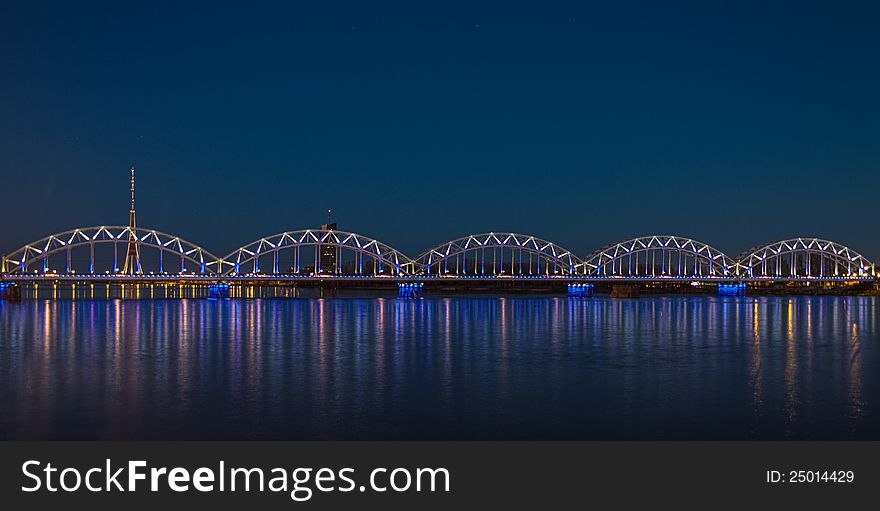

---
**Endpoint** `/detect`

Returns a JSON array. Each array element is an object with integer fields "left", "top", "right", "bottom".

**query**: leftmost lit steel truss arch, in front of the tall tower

[{"left": 2, "top": 226, "right": 217, "bottom": 273}]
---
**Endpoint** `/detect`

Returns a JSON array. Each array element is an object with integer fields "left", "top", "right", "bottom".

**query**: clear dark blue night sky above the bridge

[{"left": 0, "top": 1, "right": 880, "bottom": 259}]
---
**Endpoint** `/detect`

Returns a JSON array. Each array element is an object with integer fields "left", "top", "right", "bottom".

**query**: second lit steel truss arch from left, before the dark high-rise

[{"left": 217, "top": 229, "right": 414, "bottom": 275}]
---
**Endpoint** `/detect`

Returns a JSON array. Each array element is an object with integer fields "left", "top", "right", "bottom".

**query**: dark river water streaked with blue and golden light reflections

[{"left": 0, "top": 296, "right": 880, "bottom": 439}]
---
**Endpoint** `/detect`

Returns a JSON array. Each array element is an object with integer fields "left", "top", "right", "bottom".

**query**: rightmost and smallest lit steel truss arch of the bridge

[{"left": 737, "top": 237, "right": 876, "bottom": 278}]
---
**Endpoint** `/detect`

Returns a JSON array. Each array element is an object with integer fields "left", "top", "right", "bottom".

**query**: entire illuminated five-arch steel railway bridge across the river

[{"left": 0, "top": 226, "right": 877, "bottom": 285}]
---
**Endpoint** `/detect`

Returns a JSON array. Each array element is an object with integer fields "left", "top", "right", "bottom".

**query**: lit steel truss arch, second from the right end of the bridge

[{"left": 584, "top": 235, "right": 736, "bottom": 277}]
